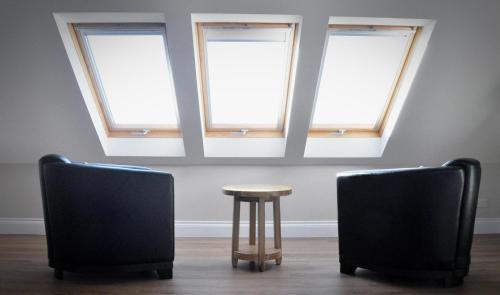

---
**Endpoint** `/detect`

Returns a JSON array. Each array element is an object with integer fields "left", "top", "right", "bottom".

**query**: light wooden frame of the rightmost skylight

[{"left": 308, "top": 24, "right": 422, "bottom": 138}]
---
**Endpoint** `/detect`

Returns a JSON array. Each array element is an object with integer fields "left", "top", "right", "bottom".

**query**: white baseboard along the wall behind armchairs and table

[{"left": 0, "top": 218, "right": 500, "bottom": 238}]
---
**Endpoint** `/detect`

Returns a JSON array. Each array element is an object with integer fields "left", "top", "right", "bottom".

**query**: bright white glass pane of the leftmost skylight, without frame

[{"left": 86, "top": 33, "right": 177, "bottom": 128}]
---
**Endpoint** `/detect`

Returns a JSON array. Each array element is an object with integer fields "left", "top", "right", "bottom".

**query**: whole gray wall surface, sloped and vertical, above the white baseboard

[{"left": 0, "top": 0, "right": 500, "bottom": 220}]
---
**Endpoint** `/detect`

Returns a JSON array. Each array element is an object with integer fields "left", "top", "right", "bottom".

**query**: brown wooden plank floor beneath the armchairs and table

[{"left": 0, "top": 235, "right": 500, "bottom": 294}]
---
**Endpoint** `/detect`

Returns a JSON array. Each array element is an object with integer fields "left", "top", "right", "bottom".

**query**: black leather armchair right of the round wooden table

[{"left": 337, "top": 159, "right": 481, "bottom": 287}]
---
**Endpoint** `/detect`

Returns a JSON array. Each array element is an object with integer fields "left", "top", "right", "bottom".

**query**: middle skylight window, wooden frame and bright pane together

[{"left": 196, "top": 23, "right": 296, "bottom": 137}]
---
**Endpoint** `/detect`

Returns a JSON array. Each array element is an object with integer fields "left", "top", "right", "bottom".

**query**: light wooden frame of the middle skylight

[{"left": 195, "top": 22, "right": 299, "bottom": 138}]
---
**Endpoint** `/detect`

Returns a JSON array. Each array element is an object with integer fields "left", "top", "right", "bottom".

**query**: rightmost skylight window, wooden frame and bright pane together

[{"left": 309, "top": 25, "right": 417, "bottom": 137}]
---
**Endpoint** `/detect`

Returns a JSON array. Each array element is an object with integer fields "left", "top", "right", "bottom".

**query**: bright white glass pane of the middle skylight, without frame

[{"left": 205, "top": 28, "right": 289, "bottom": 128}]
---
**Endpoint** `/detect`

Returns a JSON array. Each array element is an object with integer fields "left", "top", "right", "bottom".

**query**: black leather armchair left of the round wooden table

[{"left": 39, "top": 155, "right": 174, "bottom": 279}]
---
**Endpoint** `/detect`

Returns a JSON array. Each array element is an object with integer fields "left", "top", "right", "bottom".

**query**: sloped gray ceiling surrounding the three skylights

[{"left": 0, "top": 0, "right": 500, "bottom": 165}]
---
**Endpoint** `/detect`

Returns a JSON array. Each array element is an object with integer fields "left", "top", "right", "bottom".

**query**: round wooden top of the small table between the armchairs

[{"left": 222, "top": 184, "right": 292, "bottom": 198}]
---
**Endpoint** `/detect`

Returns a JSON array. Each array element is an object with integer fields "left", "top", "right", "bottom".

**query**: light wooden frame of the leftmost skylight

[{"left": 68, "top": 23, "right": 182, "bottom": 138}]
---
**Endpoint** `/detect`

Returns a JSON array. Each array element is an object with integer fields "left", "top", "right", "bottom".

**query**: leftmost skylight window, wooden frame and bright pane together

[{"left": 73, "top": 24, "right": 180, "bottom": 137}]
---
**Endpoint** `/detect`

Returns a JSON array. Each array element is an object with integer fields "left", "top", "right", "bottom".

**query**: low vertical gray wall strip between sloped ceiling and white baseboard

[{"left": 0, "top": 164, "right": 500, "bottom": 221}]
